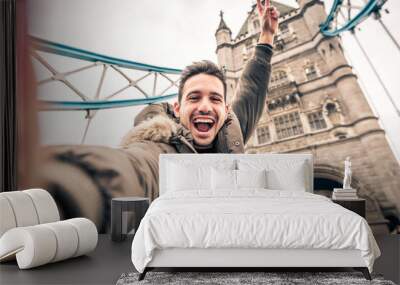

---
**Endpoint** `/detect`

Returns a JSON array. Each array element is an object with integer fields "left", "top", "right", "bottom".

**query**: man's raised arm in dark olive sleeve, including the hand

[{"left": 232, "top": 0, "right": 279, "bottom": 143}]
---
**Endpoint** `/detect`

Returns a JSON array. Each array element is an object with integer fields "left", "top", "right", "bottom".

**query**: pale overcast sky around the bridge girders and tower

[{"left": 28, "top": 0, "right": 400, "bottom": 160}]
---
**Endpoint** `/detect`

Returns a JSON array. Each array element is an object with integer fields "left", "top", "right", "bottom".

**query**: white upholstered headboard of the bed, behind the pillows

[{"left": 159, "top": 154, "right": 314, "bottom": 195}]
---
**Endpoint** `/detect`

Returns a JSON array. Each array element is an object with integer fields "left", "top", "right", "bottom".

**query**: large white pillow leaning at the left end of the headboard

[{"left": 167, "top": 163, "right": 211, "bottom": 191}]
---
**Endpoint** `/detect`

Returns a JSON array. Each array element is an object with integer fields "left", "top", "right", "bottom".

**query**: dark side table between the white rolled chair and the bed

[{"left": 111, "top": 197, "right": 149, "bottom": 241}]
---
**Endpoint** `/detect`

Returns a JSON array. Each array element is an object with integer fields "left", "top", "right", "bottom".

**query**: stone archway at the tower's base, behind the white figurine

[{"left": 314, "top": 164, "right": 388, "bottom": 233}]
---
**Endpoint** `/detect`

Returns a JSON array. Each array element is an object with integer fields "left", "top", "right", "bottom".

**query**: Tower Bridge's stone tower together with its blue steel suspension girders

[{"left": 32, "top": 0, "right": 400, "bottom": 232}]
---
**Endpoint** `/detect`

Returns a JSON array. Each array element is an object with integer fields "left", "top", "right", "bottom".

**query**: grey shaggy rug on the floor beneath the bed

[{"left": 117, "top": 271, "right": 395, "bottom": 285}]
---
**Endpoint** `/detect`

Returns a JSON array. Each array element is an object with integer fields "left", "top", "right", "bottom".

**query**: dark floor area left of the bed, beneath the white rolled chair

[{"left": 0, "top": 235, "right": 135, "bottom": 285}]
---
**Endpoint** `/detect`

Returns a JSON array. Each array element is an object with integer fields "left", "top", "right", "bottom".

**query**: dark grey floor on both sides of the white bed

[{"left": 0, "top": 235, "right": 400, "bottom": 285}]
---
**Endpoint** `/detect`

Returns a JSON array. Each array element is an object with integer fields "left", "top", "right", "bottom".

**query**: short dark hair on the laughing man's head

[{"left": 178, "top": 60, "right": 226, "bottom": 102}]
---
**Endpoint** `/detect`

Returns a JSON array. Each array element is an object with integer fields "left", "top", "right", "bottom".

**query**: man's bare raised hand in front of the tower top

[{"left": 257, "top": 0, "right": 279, "bottom": 45}]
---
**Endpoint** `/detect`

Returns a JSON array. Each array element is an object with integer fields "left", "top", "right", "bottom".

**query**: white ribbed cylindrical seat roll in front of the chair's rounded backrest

[{"left": 0, "top": 218, "right": 98, "bottom": 269}]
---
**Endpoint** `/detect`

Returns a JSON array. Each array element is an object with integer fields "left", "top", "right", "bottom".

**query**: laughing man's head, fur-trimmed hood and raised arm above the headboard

[{"left": 121, "top": 0, "right": 279, "bottom": 153}]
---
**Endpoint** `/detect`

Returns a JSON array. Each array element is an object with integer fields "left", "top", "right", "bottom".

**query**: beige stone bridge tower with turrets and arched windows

[{"left": 215, "top": 0, "right": 400, "bottom": 232}]
